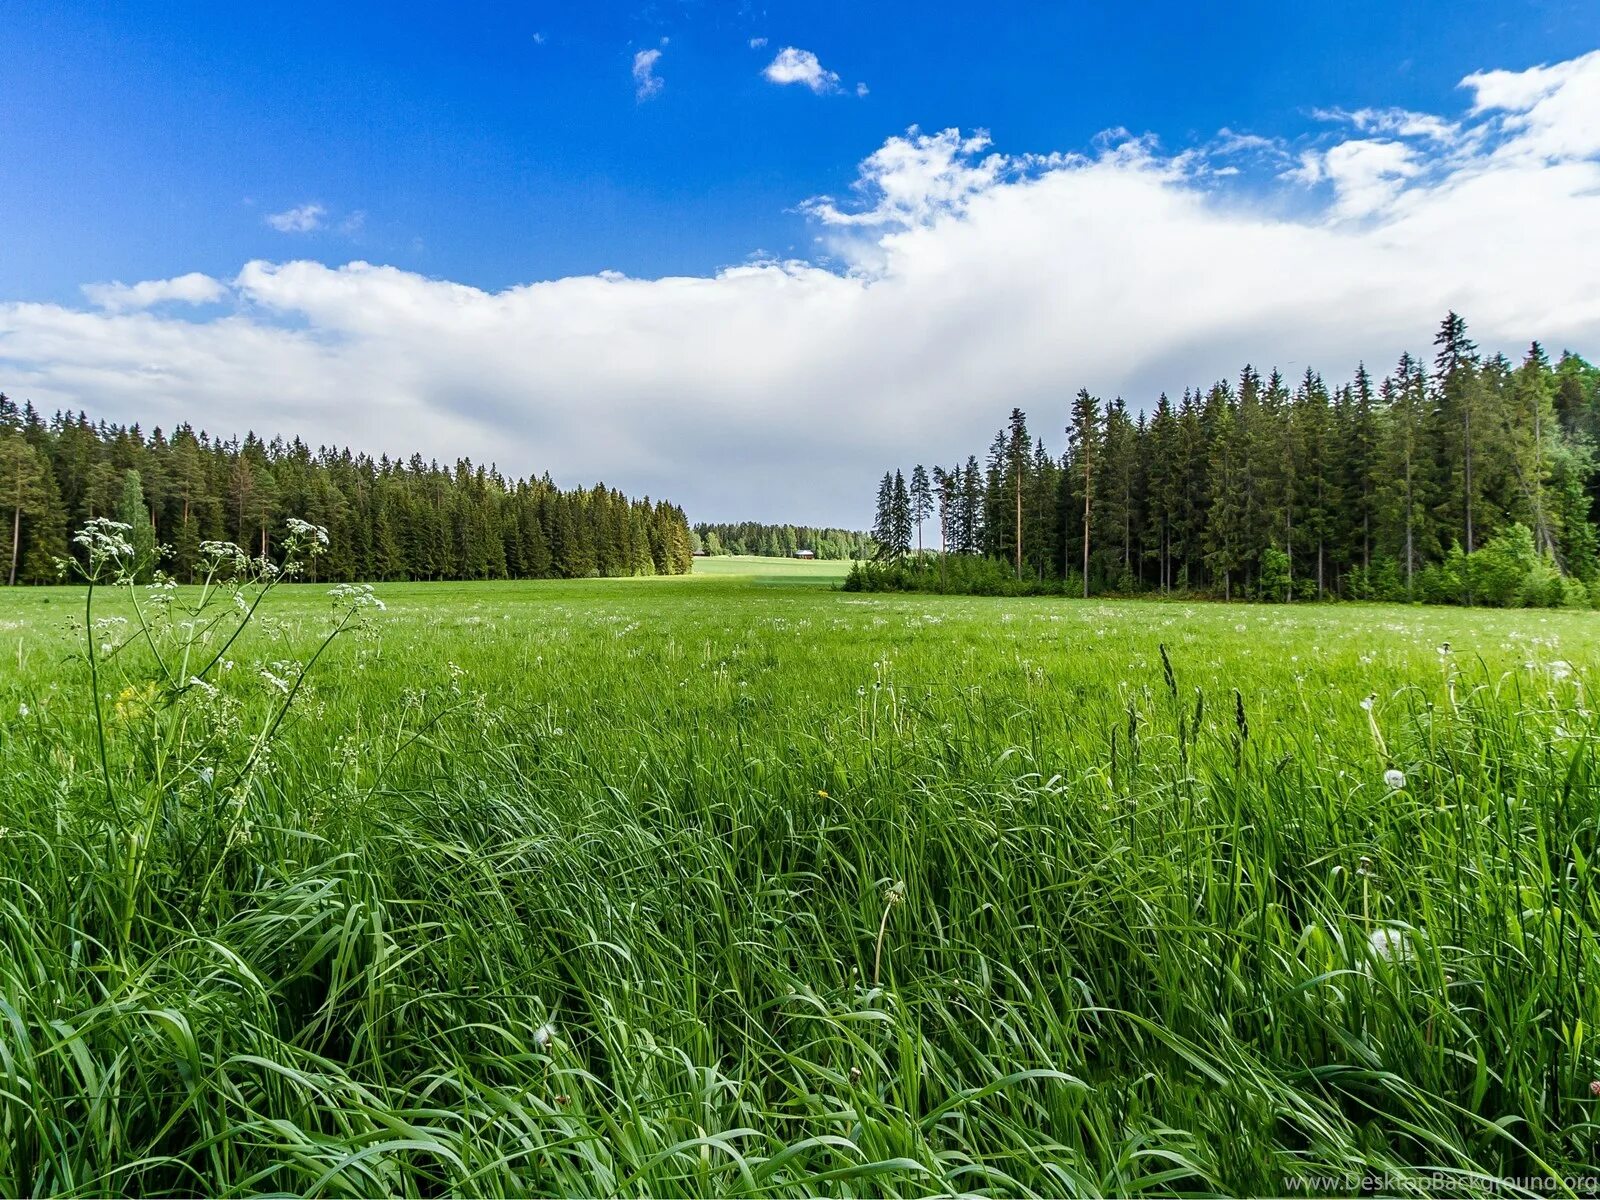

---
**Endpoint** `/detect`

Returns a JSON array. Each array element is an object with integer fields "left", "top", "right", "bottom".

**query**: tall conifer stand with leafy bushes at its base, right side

[{"left": 851, "top": 312, "right": 1600, "bottom": 605}]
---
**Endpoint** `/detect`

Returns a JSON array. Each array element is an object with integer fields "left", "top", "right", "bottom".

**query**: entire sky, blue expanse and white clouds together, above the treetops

[{"left": 0, "top": 0, "right": 1600, "bottom": 525}]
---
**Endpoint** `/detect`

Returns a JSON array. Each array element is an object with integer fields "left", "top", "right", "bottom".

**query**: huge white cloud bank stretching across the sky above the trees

[{"left": 0, "top": 56, "right": 1600, "bottom": 525}]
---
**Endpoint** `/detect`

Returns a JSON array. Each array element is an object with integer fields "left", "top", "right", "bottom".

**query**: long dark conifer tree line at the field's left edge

[{"left": 0, "top": 394, "right": 693, "bottom": 584}]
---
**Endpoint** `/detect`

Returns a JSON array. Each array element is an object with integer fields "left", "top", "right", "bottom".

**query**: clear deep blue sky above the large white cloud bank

[{"left": 9, "top": 0, "right": 1600, "bottom": 299}]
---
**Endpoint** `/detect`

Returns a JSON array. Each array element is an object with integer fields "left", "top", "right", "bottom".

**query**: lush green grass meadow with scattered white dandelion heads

[{"left": 0, "top": 560, "right": 1600, "bottom": 1197}]
